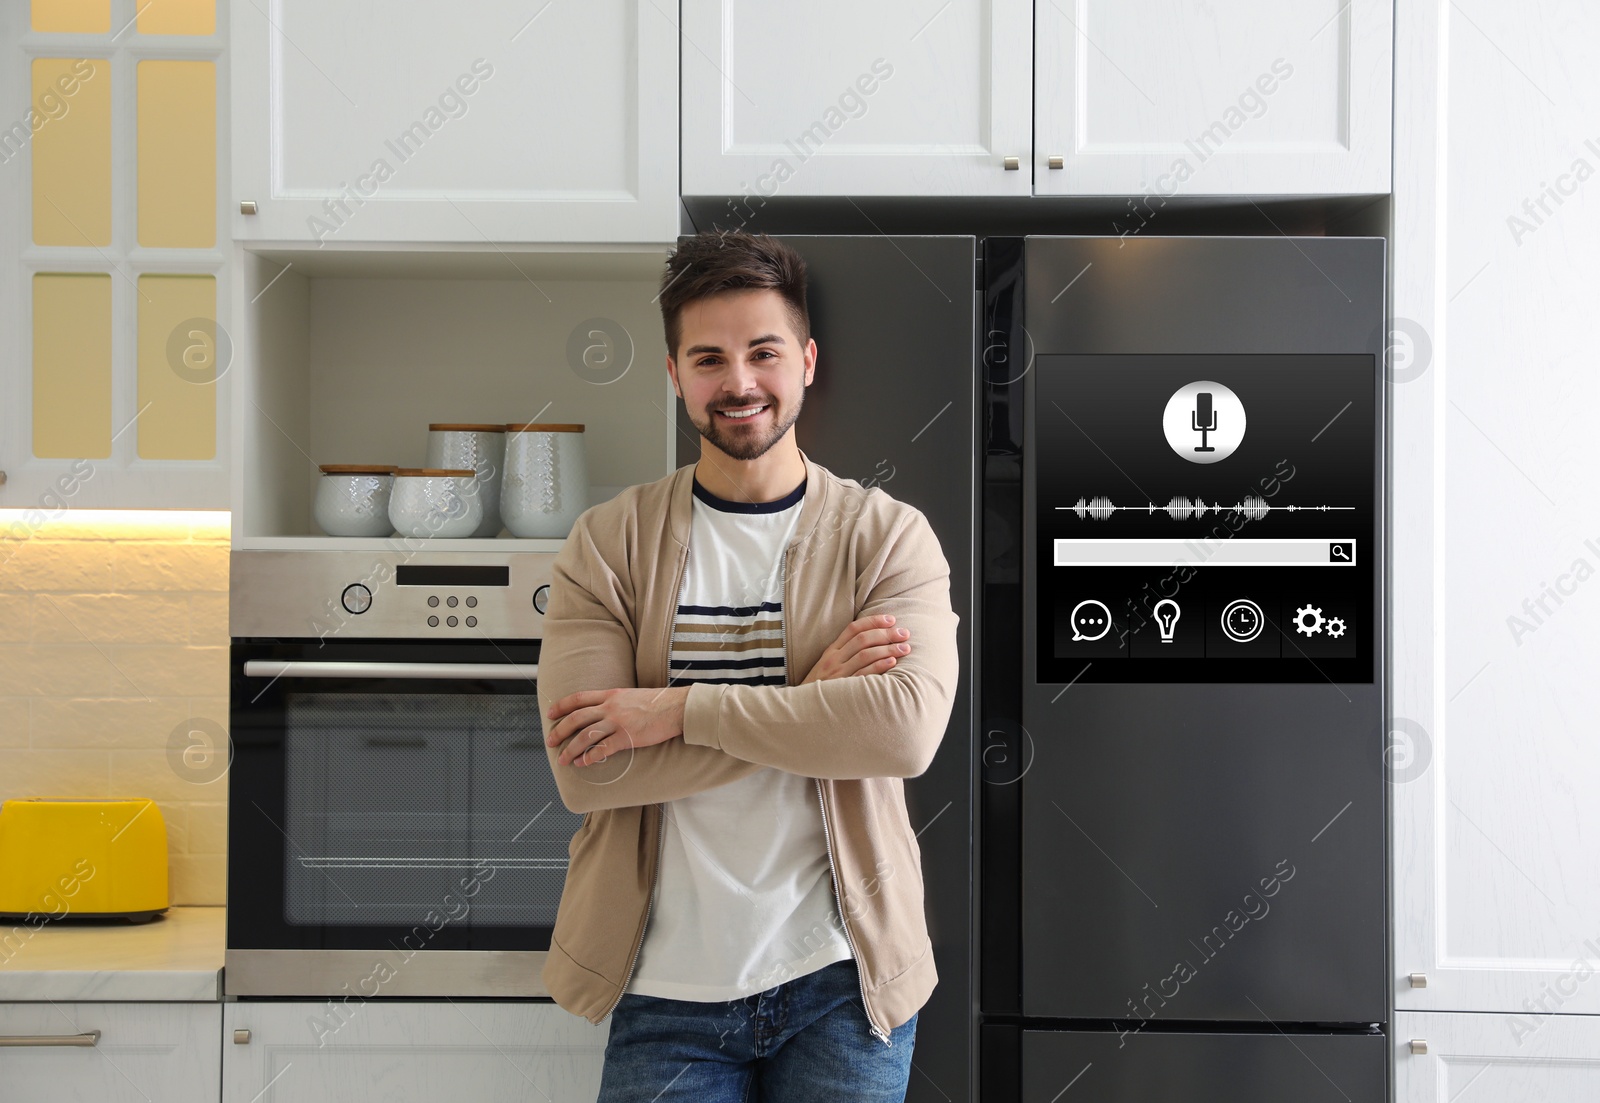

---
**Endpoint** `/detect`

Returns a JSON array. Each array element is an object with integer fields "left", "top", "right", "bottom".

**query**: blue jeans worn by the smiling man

[{"left": 598, "top": 957, "right": 917, "bottom": 1103}]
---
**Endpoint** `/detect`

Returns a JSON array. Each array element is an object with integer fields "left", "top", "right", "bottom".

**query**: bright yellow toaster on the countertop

[{"left": 0, "top": 797, "right": 170, "bottom": 922}]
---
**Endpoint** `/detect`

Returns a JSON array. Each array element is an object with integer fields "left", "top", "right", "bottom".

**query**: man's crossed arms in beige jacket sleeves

[{"left": 539, "top": 507, "right": 958, "bottom": 813}]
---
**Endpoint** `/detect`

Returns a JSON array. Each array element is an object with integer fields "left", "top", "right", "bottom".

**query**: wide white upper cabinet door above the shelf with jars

[{"left": 229, "top": 0, "right": 678, "bottom": 245}]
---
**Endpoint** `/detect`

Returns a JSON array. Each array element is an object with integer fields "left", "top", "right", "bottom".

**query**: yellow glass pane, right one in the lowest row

[{"left": 136, "top": 275, "right": 217, "bottom": 459}]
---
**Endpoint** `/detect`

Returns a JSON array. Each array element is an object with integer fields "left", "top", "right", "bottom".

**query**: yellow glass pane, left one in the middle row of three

[{"left": 27, "top": 58, "right": 110, "bottom": 247}]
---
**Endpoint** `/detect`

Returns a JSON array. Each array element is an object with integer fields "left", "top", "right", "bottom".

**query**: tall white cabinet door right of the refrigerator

[{"left": 1390, "top": 0, "right": 1600, "bottom": 1018}]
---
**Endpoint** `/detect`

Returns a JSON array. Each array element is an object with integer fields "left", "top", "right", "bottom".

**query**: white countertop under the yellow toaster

[{"left": 0, "top": 908, "right": 227, "bottom": 1002}]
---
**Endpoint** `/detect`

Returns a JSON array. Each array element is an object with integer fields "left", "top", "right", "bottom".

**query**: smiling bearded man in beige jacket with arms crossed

[{"left": 539, "top": 234, "right": 958, "bottom": 1103}]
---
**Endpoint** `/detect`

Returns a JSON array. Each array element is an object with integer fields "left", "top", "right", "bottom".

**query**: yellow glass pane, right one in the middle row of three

[{"left": 139, "top": 61, "right": 216, "bottom": 248}]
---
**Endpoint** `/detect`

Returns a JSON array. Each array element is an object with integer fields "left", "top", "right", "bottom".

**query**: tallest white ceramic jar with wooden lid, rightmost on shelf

[{"left": 501, "top": 423, "right": 589, "bottom": 539}]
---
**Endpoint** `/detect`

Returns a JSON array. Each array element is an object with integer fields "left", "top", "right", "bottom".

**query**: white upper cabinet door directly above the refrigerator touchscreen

[{"left": 1034, "top": 0, "right": 1394, "bottom": 197}]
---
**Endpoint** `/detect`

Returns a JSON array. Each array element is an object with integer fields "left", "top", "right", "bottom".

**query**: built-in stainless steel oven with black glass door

[{"left": 224, "top": 549, "right": 581, "bottom": 999}]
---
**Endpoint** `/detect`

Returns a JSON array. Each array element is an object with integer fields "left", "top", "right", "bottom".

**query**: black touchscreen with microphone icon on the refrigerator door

[{"left": 1032, "top": 355, "right": 1381, "bottom": 684}]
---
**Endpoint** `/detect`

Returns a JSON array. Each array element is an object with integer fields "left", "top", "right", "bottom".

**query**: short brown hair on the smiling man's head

[{"left": 661, "top": 231, "right": 811, "bottom": 357}]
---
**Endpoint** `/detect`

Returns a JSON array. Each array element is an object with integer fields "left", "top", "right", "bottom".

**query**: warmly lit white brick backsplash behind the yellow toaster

[{"left": 0, "top": 528, "right": 229, "bottom": 904}]
